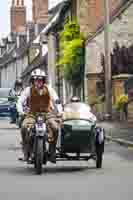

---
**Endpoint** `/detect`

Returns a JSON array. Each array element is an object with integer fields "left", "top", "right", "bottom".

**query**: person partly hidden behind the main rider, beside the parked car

[{"left": 9, "top": 78, "right": 23, "bottom": 123}]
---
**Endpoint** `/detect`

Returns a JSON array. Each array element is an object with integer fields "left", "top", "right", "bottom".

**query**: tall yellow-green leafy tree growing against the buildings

[{"left": 58, "top": 22, "right": 84, "bottom": 85}]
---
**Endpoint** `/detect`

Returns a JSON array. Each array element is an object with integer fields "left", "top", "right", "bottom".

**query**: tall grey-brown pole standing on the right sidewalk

[{"left": 104, "top": 0, "right": 112, "bottom": 119}]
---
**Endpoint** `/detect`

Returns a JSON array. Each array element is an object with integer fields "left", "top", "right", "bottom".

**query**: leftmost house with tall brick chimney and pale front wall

[{"left": 0, "top": 0, "right": 28, "bottom": 87}]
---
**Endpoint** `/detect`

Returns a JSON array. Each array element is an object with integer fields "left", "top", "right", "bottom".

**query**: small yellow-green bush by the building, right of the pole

[{"left": 115, "top": 95, "right": 128, "bottom": 111}]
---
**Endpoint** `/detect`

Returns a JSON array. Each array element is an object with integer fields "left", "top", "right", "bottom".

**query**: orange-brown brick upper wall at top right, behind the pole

[{"left": 77, "top": 0, "right": 128, "bottom": 37}]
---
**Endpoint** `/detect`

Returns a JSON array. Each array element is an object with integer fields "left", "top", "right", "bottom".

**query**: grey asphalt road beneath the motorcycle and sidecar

[{"left": 0, "top": 120, "right": 133, "bottom": 200}]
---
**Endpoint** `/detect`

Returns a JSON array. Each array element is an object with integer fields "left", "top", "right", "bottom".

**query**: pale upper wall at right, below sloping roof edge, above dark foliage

[{"left": 86, "top": 1, "right": 133, "bottom": 56}]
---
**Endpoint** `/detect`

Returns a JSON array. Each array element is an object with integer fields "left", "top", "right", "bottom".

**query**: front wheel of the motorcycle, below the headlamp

[{"left": 34, "top": 138, "right": 44, "bottom": 174}]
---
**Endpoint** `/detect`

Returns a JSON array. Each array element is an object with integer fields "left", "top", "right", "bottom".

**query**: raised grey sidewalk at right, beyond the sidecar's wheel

[{"left": 98, "top": 121, "right": 133, "bottom": 147}]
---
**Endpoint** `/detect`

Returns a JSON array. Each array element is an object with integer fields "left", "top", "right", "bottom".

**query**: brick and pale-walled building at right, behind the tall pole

[{"left": 72, "top": 0, "right": 133, "bottom": 119}]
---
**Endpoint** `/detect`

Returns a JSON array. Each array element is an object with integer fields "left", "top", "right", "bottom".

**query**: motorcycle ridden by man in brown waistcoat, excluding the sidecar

[{"left": 25, "top": 113, "right": 48, "bottom": 174}]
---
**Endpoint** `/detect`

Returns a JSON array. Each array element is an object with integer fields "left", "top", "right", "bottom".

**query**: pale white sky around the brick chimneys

[{"left": 0, "top": 0, "right": 62, "bottom": 38}]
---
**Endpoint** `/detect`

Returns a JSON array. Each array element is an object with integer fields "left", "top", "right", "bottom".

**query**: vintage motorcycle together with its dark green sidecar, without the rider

[{"left": 24, "top": 103, "right": 105, "bottom": 174}]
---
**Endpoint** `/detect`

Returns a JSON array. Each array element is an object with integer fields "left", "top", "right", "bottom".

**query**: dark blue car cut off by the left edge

[{"left": 0, "top": 88, "right": 11, "bottom": 117}]
